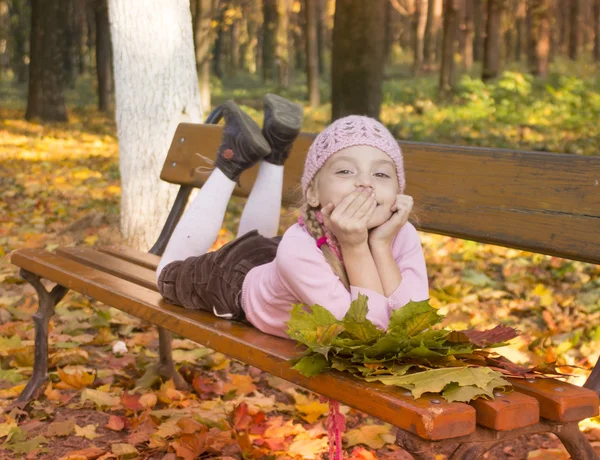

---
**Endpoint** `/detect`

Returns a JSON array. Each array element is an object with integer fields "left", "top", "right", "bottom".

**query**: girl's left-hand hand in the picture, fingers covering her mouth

[{"left": 321, "top": 187, "right": 377, "bottom": 247}]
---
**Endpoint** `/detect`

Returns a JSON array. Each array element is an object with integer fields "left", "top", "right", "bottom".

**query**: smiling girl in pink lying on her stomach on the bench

[{"left": 157, "top": 95, "right": 429, "bottom": 338}]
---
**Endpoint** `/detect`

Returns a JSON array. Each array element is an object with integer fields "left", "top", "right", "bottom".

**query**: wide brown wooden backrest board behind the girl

[{"left": 161, "top": 123, "right": 600, "bottom": 264}]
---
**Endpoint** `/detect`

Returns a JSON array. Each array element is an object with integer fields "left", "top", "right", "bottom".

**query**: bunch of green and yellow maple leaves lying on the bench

[{"left": 287, "top": 295, "right": 558, "bottom": 402}]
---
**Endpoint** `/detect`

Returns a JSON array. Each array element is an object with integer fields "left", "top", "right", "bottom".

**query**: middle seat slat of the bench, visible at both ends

[{"left": 56, "top": 248, "right": 539, "bottom": 430}]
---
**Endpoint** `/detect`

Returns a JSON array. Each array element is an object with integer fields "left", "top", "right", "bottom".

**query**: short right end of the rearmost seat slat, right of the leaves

[{"left": 509, "top": 378, "right": 600, "bottom": 422}]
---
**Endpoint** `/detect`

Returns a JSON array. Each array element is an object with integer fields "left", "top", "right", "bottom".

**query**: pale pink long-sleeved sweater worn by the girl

[{"left": 242, "top": 223, "right": 429, "bottom": 338}]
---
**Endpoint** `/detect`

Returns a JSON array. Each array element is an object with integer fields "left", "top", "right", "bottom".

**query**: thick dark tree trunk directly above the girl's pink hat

[{"left": 331, "top": 0, "right": 387, "bottom": 120}]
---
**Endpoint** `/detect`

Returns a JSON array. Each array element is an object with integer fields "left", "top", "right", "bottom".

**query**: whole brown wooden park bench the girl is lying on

[{"left": 11, "top": 112, "right": 600, "bottom": 460}]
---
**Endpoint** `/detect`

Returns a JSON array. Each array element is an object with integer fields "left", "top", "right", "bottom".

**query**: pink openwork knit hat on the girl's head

[{"left": 301, "top": 115, "right": 405, "bottom": 195}]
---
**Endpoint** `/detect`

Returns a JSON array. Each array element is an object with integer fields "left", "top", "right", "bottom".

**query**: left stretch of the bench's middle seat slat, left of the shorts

[{"left": 56, "top": 248, "right": 157, "bottom": 291}]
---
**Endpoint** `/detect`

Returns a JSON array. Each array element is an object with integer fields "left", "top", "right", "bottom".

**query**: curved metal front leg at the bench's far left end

[{"left": 17, "top": 269, "right": 69, "bottom": 403}]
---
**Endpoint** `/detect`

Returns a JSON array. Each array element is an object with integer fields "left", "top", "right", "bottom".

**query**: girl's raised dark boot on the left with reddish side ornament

[{"left": 215, "top": 101, "right": 271, "bottom": 183}]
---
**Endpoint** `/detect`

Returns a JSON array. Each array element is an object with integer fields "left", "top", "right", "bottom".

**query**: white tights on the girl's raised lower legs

[{"left": 156, "top": 161, "right": 283, "bottom": 279}]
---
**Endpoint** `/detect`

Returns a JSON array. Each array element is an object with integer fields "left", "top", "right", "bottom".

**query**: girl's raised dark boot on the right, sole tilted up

[{"left": 263, "top": 94, "right": 302, "bottom": 165}]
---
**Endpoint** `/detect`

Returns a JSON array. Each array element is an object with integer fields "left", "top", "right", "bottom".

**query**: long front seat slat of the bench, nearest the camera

[{"left": 11, "top": 249, "right": 475, "bottom": 440}]
